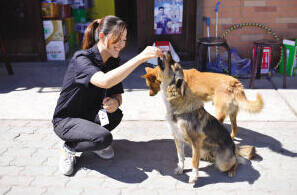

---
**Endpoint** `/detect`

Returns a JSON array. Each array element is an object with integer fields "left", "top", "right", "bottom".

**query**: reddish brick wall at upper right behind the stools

[{"left": 201, "top": 0, "right": 297, "bottom": 57}]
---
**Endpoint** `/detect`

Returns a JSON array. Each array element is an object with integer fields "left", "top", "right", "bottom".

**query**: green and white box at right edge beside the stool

[{"left": 280, "top": 39, "right": 297, "bottom": 76}]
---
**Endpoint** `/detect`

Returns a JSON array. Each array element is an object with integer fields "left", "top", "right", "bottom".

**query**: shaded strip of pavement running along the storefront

[{"left": 0, "top": 59, "right": 297, "bottom": 94}]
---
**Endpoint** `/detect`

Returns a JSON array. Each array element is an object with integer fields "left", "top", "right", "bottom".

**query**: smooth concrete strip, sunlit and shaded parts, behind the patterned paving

[{"left": 0, "top": 62, "right": 297, "bottom": 121}]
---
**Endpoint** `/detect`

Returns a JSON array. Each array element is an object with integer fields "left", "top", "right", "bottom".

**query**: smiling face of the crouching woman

[{"left": 105, "top": 30, "right": 127, "bottom": 58}]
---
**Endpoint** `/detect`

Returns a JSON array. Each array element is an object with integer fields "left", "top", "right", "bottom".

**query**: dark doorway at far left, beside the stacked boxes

[{"left": 0, "top": 0, "right": 46, "bottom": 61}]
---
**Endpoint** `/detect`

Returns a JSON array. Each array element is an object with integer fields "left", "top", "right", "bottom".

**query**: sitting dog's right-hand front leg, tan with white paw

[{"left": 189, "top": 141, "right": 201, "bottom": 183}]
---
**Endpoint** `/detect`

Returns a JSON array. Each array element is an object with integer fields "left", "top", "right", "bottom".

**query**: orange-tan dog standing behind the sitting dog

[{"left": 142, "top": 66, "right": 264, "bottom": 139}]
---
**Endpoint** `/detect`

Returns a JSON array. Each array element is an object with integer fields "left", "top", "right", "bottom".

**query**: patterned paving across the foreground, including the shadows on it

[{"left": 0, "top": 120, "right": 297, "bottom": 195}]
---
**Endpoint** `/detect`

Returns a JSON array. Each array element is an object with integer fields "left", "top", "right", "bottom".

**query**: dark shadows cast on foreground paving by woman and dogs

[{"left": 72, "top": 125, "right": 297, "bottom": 187}]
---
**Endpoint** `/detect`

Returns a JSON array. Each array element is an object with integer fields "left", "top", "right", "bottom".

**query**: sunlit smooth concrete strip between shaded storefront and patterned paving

[{"left": 0, "top": 88, "right": 297, "bottom": 121}]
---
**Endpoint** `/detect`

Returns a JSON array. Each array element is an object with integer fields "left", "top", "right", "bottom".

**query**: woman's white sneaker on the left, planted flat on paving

[{"left": 59, "top": 144, "right": 76, "bottom": 175}]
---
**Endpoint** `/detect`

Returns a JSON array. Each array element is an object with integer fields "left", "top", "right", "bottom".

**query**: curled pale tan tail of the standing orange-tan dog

[{"left": 233, "top": 81, "right": 264, "bottom": 113}]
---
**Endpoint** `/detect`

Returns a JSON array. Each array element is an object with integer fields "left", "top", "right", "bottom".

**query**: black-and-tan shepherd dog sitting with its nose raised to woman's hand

[{"left": 159, "top": 53, "right": 246, "bottom": 183}]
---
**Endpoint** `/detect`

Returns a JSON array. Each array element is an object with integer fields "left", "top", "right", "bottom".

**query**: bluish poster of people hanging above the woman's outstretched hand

[{"left": 154, "top": 0, "right": 183, "bottom": 35}]
